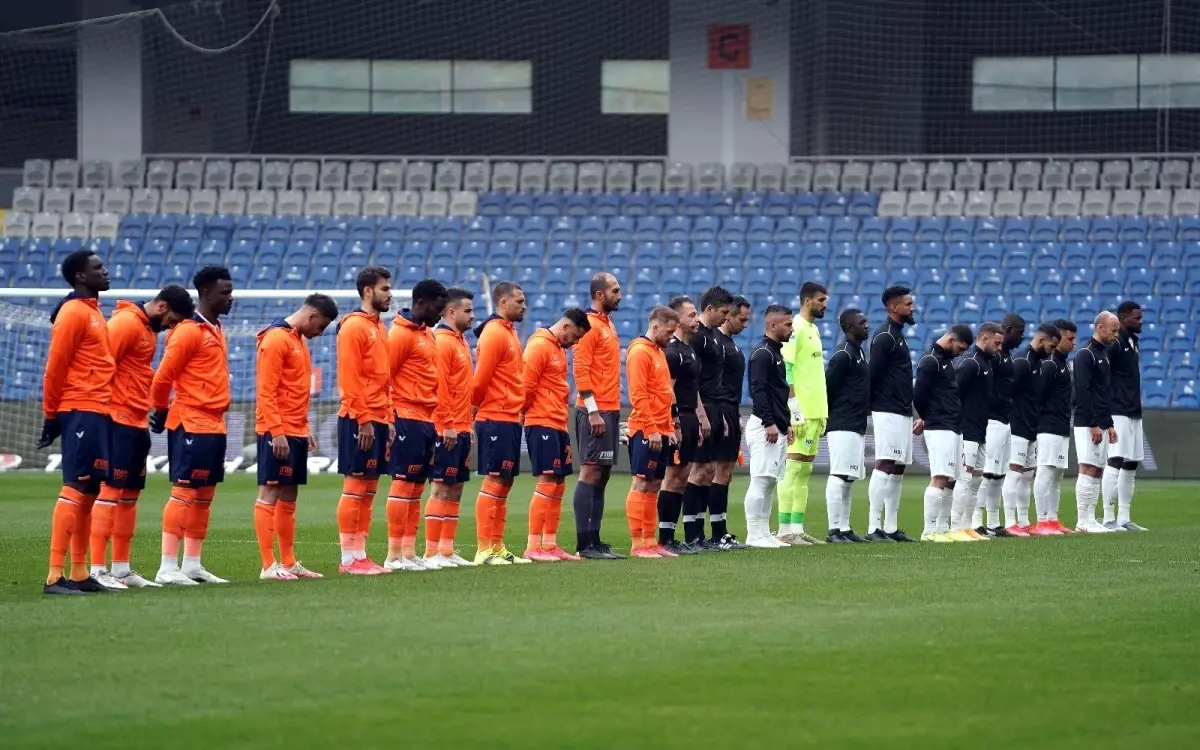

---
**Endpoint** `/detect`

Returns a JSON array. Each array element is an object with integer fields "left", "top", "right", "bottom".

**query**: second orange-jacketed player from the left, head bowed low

[{"left": 91, "top": 284, "right": 196, "bottom": 589}]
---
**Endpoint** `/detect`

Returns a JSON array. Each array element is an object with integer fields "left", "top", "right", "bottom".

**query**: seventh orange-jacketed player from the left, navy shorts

[{"left": 425, "top": 287, "right": 475, "bottom": 568}]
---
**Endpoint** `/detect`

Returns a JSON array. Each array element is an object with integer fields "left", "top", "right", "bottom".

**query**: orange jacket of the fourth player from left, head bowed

[{"left": 254, "top": 319, "right": 312, "bottom": 438}]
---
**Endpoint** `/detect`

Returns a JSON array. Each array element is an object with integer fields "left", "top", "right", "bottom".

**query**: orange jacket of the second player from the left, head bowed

[{"left": 108, "top": 300, "right": 158, "bottom": 428}]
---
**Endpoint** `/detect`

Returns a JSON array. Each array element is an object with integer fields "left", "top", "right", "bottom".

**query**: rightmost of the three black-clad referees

[{"left": 708, "top": 296, "right": 750, "bottom": 550}]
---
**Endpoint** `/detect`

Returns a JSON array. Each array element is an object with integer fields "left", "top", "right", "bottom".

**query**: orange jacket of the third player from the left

[{"left": 150, "top": 313, "right": 229, "bottom": 434}]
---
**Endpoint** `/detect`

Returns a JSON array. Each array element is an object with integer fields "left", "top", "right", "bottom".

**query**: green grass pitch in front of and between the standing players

[{"left": 0, "top": 474, "right": 1200, "bottom": 750}]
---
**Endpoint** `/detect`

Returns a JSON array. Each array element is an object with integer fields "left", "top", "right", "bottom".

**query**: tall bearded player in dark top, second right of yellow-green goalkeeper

[{"left": 866, "top": 287, "right": 917, "bottom": 541}]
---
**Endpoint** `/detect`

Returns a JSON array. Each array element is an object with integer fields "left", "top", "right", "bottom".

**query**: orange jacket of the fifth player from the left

[{"left": 337, "top": 310, "right": 391, "bottom": 425}]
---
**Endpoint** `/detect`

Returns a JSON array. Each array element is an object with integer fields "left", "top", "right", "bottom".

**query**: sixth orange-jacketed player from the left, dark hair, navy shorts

[{"left": 383, "top": 278, "right": 452, "bottom": 571}]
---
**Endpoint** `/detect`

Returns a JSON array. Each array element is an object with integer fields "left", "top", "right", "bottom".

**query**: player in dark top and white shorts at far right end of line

[{"left": 1100, "top": 300, "right": 1146, "bottom": 532}]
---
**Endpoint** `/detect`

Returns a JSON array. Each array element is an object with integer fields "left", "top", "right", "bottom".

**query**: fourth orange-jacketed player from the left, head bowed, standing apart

[{"left": 254, "top": 294, "right": 337, "bottom": 581}]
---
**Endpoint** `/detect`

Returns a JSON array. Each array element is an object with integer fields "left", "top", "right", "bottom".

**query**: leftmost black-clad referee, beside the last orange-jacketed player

[{"left": 659, "top": 296, "right": 712, "bottom": 554}]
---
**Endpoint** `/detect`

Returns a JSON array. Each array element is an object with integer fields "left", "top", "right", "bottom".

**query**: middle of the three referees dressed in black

[{"left": 683, "top": 287, "right": 733, "bottom": 550}]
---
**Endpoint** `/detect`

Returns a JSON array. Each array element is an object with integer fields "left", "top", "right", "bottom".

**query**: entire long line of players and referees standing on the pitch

[{"left": 40, "top": 251, "right": 1141, "bottom": 594}]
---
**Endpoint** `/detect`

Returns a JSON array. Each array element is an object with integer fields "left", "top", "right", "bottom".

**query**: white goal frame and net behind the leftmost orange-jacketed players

[{"left": 0, "top": 288, "right": 410, "bottom": 472}]
